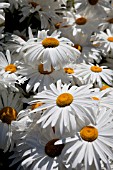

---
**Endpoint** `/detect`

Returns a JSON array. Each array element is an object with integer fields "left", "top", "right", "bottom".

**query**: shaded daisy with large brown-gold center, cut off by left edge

[{"left": 0, "top": 90, "right": 23, "bottom": 151}]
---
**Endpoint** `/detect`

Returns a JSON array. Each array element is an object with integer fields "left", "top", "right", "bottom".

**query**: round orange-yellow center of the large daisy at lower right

[{"left": 80, "top": 126, "right": 98, "bottom": 142}]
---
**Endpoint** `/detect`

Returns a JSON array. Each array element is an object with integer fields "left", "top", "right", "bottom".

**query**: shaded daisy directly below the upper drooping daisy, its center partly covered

[{"left": 19, "top": 63, "right": 70, "bottom": 92}]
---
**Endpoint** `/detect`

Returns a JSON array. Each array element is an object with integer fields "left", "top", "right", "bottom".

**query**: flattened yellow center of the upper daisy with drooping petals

[{"left": 42, "top": 37, "right": 59, "bottom": 48}]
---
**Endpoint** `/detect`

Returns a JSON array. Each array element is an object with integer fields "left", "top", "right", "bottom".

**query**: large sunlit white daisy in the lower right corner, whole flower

[{"left": 55, "top": 108, "right": 113, "bottom": 170}]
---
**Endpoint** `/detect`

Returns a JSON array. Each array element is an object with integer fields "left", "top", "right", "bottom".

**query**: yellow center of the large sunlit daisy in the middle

[{"left": 56, "top": 93, "right": 73, "bottom": 107}]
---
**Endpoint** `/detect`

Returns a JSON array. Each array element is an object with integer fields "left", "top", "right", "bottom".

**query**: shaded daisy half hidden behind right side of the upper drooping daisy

[{"left": 63, "top": 29, "right": 102, "bottom": 63}]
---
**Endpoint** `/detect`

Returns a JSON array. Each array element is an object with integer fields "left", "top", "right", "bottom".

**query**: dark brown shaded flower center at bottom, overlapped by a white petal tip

[{"left": 45, "top": 139, "right": 64, "bottom": 158}]
